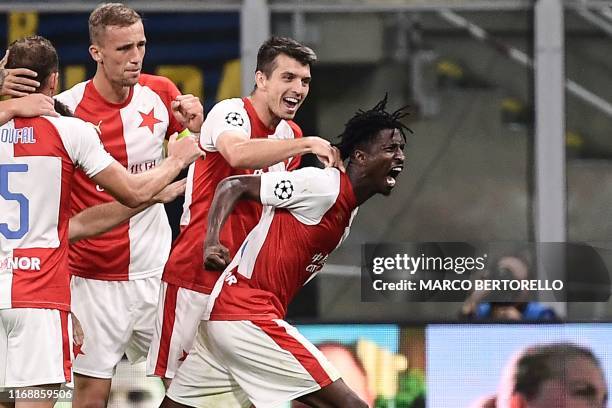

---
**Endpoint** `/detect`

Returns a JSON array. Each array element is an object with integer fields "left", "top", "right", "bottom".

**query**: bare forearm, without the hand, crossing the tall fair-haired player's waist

[{"left": 68, "top": 201, "right": 149, "bottom": 243}]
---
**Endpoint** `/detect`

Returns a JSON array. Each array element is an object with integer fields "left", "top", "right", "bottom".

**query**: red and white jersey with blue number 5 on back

[{"left": 0, "top": 116, "right": 113, "bottom": 311}]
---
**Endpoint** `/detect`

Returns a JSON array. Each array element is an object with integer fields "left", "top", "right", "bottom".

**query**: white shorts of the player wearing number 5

[{"left": 0, "top": 308, "right": 72, "bottom": 388}]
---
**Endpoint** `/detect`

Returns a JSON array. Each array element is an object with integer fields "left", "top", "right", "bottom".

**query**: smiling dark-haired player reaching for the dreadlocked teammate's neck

[{"left": 147, "top": 37, "right": 342, "bottom": 384}]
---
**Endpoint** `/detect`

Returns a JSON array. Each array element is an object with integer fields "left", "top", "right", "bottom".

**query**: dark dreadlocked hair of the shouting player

[{"left": 335, "top": 94, "right": 414, "bottom": 160}]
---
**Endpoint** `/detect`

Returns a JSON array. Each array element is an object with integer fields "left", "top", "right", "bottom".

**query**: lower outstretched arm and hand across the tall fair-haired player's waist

[{"left": 68, "top": 179, "right": 187, "bottom": 243}]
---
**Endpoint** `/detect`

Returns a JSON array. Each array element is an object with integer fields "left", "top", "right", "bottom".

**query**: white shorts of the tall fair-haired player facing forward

[{"left": 70, "top": 276, "right": 160, "bottom": 378}]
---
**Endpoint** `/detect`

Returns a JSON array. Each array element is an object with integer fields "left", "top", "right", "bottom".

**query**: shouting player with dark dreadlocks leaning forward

[{"left": 162, "top": 98, "right": 405, "bottom": 408}]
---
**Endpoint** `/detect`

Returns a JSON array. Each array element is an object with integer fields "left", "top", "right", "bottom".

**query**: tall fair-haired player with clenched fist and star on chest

[{"left": 52, "top": 3, "right": 203, "bottom": 407}]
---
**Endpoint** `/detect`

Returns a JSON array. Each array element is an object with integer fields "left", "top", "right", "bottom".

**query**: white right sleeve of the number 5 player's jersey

[{"left": 55, "top": 118, "right": 114, "bottom": 177}]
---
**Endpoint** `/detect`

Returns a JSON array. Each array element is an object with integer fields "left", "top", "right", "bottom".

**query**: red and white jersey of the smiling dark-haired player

[{"left": 162, "top": 98, "right": 302, "bottom": 293}]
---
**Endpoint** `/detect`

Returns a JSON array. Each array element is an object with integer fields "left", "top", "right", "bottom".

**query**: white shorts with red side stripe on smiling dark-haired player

[{"left": 147, "top": 282, "right": 210, "bottom": 378}]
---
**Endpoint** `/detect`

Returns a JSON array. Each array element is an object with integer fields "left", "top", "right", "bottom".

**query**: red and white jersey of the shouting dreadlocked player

[{"left": 205, "top": 168, "right": 357, "bottom": 320}]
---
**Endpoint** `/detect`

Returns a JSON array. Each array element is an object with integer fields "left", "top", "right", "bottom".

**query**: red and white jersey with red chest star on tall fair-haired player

[{"left": 57, "top": 74, "right": 182, "bottom": 280}]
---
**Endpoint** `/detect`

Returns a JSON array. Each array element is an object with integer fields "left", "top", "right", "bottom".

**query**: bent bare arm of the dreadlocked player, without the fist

[{"left": 204, "top": 176, "right": 261, "bottom": 247}]
